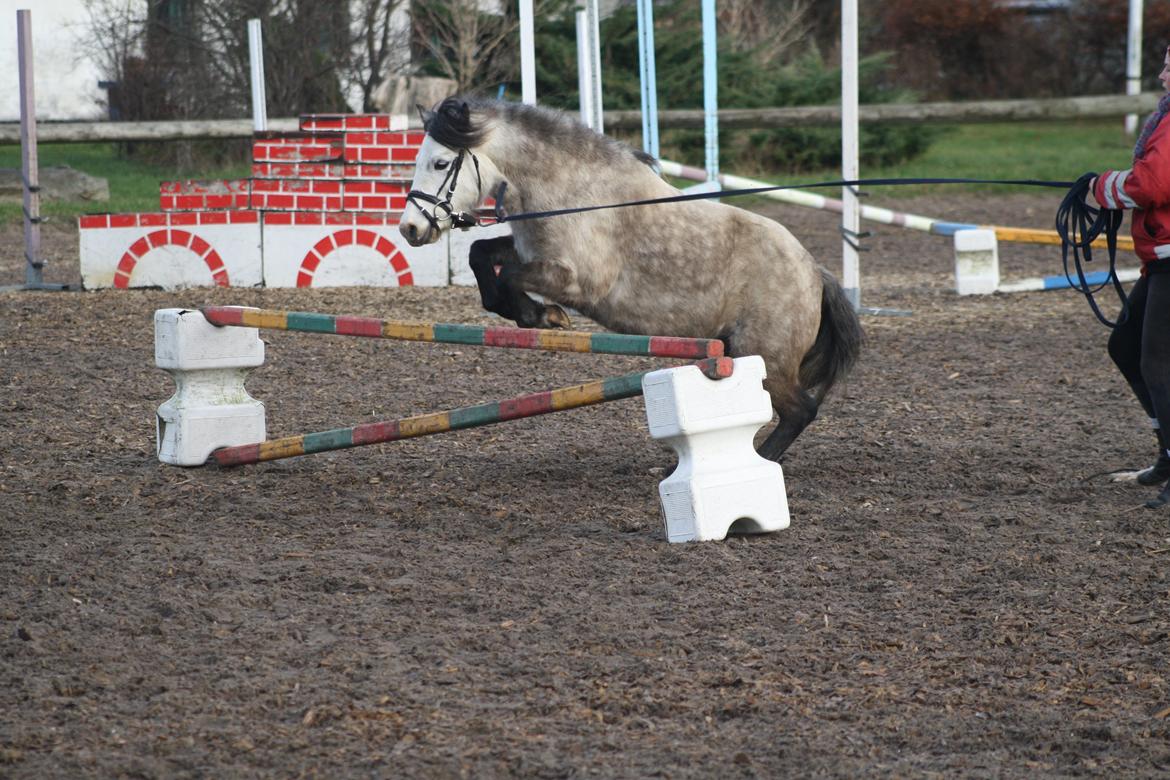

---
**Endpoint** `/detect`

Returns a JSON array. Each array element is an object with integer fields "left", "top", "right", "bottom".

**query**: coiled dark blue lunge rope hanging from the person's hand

[{"left": 1057, "top": 173, "right": 1129, "bottom": 327}]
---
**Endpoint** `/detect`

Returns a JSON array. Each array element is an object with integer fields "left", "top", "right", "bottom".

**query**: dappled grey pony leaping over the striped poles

[{"left": 399, "top": 98, "right": 862, "bottom": 460}]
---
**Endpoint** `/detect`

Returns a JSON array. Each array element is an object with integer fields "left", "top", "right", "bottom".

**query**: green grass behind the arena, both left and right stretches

[{"left": 0, "top": 118, "right": 1133, "bottom": 223}]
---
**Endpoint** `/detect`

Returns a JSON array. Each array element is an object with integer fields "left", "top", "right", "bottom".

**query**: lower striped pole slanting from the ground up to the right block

[{"left": 212, "top": 358, "right": 732, "bottom": 465}]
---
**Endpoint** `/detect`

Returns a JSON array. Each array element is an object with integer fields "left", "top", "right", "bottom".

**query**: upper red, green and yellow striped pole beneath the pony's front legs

[{"left": 202, "top": 306, "right": 723, "bottom": 360}]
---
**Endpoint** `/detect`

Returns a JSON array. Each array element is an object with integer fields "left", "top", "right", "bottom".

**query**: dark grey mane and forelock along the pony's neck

[{"left": 422, "top": 97, "right": 658, "bottom": 168}]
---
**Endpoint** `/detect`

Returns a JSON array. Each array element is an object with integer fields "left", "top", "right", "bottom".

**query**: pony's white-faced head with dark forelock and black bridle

[{"left": 398, "top": 98, "right": 497, "bottom": 247}]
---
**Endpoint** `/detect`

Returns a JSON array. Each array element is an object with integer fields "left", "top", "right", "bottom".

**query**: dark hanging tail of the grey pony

[{"left": 799, "top": 268, "right": 865, "bottom": 403}]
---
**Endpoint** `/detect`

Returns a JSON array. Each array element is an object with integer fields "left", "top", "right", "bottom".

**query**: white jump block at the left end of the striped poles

[{"left": 154, "top": 309, "right": 266, "bottom": 465}]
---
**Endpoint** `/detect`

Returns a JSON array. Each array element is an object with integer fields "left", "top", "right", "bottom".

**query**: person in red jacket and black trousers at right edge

[{"left": 1093, "top": 49, "right": 1170, "bottom": 509}]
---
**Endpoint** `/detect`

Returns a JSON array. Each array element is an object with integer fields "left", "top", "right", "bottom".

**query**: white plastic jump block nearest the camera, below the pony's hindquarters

[{"left": 642, "top": 356, "right": 789, "bottom": 543}]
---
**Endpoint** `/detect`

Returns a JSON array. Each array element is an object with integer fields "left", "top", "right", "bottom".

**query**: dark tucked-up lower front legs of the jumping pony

[{"left": 468, "top": 236, "right": 570, "bottom": 327}]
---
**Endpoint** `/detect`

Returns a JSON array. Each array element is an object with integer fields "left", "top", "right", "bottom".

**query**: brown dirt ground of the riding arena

[{"left": 0, "top": 193, "right": 1170, "bottom": 778}]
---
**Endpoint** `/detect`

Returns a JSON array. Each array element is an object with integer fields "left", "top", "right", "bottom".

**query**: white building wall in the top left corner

[{"left": 0, "top": 0, "right": 105, "bottom": 120}]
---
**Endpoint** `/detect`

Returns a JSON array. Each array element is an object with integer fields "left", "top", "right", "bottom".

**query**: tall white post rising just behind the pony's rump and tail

[{"left": 841, "top": 0, "right": 861, "bottom": 309}]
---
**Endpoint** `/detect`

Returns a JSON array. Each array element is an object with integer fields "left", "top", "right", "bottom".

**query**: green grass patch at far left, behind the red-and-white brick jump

[{"left": 0, "top": 144, "right": 250, "bottom": 223}]
